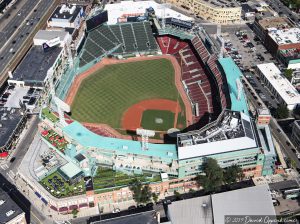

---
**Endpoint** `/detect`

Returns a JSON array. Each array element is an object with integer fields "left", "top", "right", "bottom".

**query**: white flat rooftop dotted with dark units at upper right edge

[{"left": 268, "top": 27, "right": 300, "bottom": 45}]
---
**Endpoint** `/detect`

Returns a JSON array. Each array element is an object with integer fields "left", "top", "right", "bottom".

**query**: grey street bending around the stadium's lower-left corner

[{"left": 0, "top": 116, "right": 46, "bottom": 224}]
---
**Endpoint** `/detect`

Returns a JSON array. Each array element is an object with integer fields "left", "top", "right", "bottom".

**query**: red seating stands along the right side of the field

[{"left": 157, "top": 35, "right": 227, "bottom": 126}]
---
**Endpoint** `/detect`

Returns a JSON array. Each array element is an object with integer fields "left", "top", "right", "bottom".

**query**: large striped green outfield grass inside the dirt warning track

[{"left": 71, "top": 59, "right": 185, "bottom": 129}]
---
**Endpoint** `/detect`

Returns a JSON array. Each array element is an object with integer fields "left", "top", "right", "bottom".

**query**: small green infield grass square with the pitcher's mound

[{"left": 141, "top": 110, "right": 175, "bottom": 131}]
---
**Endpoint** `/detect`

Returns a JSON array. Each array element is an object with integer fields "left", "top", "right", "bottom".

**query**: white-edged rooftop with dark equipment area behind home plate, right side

[{"left": 177, "top": 110, "right": 258, "bottom": 159}]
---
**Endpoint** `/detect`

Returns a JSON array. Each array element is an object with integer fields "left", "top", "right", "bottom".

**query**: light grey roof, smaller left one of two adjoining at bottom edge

[{"left": 168, "top": 195, "right": 213, "bottom": 224}]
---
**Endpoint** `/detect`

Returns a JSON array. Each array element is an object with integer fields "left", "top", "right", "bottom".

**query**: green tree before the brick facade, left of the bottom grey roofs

[{"left": 130, "top": 179, "right": 152, "bottom": 204}]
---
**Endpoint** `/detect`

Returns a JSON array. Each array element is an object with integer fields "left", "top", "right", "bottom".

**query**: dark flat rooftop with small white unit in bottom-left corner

[{"left": 0, "top": 188, "right": 24, "bottom": 223}]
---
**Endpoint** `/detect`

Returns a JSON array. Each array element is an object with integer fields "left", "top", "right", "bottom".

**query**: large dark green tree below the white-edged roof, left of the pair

[{"left": 196, "top": 158, "right": 223, "bottom": 193}]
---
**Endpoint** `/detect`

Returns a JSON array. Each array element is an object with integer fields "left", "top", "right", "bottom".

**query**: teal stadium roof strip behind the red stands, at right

[{"left": 219, "top": 57, "right": 249, "bottom": 115}]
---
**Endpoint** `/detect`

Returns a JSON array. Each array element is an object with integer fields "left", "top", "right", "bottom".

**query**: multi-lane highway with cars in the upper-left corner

[{"left": 0, "top": 0, "right": 53, "bottom": 83}]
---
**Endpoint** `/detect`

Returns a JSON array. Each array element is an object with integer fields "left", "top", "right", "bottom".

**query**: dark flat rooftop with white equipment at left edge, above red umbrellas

[{"left": 0, "top": 107, "right": 23, "bottom": 148}]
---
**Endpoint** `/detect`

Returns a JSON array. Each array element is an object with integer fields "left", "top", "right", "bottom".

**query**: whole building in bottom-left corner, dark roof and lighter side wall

[{"left": 0, "top": 188, "right": 27, "bottom": 224}]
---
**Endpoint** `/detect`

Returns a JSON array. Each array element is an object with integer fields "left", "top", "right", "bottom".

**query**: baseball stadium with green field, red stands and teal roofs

[{"left": 40, "top": 1, "right": 276, "bottom": 198}]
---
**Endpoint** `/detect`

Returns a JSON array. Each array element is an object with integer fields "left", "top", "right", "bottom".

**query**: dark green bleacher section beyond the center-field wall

[{"left": 79, "top": 21, "right": 158, "bottom": 67}]
